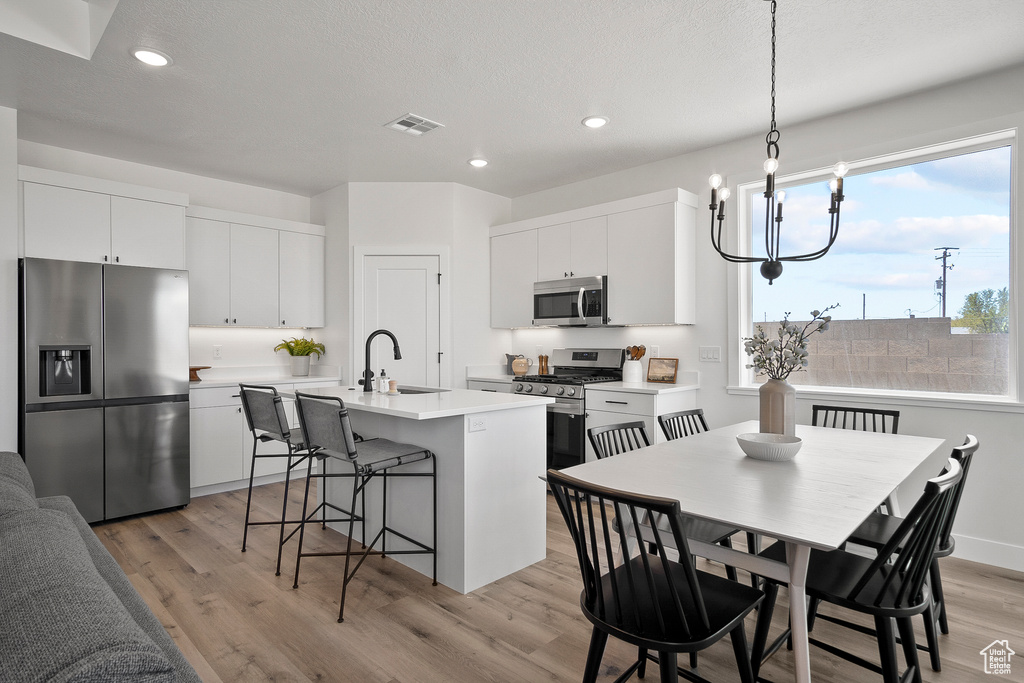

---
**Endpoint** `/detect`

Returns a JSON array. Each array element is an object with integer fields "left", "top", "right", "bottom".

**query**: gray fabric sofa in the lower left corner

[{"left": 0, "top": 453, "right": 200, "bottom": 683}]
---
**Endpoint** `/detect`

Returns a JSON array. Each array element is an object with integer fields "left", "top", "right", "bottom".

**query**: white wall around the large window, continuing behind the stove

[{"left": 512, "top": 68, "right": 1024, "bottom": 570}]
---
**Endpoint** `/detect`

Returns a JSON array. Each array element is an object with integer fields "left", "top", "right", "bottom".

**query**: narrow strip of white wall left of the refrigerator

[{"left": 0, "top": 106, "right": 20, "bottom": 451}]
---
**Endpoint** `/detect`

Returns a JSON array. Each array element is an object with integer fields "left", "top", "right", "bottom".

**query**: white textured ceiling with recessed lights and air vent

[{"left": 0, "top": 0, "right": 1024, "bottom": 197}]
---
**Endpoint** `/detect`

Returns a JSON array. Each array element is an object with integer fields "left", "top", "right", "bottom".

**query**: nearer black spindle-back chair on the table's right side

[{"left": 752, "top": 459, "right": 964, "bottom": 683}]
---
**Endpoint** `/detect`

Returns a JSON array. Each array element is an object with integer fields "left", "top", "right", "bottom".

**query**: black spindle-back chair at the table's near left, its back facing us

[{"left": 548, "top": 470, "right": 764, "bottom": 683}]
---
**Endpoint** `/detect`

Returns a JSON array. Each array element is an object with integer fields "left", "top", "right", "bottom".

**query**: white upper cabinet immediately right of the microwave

[{"left": 608, "top": 202, "right": 696, "bottom": 325}]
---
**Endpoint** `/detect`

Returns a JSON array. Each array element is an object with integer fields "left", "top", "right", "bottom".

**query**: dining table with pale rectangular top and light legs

[{"left": 563, "top": 420, "right": 952, "bottom": 683}]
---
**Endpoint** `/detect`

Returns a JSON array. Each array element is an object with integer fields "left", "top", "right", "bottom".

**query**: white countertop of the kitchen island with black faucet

[{"left": 284, "top": 386, "right": 554, "bottom": 420}]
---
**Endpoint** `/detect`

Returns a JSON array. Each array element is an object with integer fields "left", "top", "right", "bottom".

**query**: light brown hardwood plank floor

[{"left": 95, "top": 484, "right": 1024, "bottom": 683}]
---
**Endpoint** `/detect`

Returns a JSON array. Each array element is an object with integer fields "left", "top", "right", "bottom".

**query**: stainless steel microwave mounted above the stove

[{"left": 534, "top": 275, "right": 608, "bottom": 328}]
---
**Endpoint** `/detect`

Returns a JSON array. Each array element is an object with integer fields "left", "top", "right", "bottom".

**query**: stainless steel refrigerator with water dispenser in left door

[{"left": 18, "top": 258, "right": 189, "bottom": 522}]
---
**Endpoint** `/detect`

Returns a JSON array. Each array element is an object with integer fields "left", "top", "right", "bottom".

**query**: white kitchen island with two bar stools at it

[{"left": 288, "top": 386, "right": 553, "bottom": 593}]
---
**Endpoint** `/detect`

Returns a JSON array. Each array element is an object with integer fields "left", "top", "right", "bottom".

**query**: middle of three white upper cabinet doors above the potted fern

[{"left": 230, "top": 223, "right": 280, "bottom": 328}]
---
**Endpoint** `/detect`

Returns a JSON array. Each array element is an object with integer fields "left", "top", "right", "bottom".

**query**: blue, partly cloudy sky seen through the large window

[{"left": 752, "top": 146, "right": 1011, "bottom": 322}]
